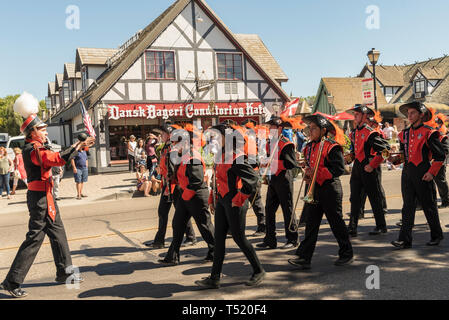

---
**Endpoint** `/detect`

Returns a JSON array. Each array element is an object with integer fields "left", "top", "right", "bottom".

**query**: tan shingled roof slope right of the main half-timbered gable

[{"left": 234, "top": 34, "right": 288, "bottom": 82}]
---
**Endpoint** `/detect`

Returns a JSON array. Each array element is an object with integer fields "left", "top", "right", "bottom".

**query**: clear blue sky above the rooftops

[{"left": 0, "top": 0, "right": 449, "bottom": 99}]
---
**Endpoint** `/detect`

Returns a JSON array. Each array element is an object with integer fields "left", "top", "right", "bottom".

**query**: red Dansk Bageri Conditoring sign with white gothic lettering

[{"left": 108, "top": 102, "right": 266, "bottom": 120}]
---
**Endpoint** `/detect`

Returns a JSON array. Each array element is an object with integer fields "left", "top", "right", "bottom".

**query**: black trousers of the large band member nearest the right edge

[{"left": 399, "top": 163, "right": 443, "bottom": 244}]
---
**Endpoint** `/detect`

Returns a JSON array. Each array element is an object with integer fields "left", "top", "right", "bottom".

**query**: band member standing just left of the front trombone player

[{"left": 257, "top": 116, "right": 298, "bottom": 249}]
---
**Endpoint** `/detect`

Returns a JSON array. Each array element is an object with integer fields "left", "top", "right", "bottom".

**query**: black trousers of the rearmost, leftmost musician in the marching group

[{"left": 154, "top": 186, "right": 196, "bottom": 244}]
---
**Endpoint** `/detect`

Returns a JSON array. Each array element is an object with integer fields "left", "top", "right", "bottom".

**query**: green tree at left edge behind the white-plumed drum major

[{"left": 0, "top": 95, "right": 47, "bottom": 137}]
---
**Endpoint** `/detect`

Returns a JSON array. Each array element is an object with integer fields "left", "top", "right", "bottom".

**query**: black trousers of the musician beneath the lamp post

[{"left": 349, "top": 160, "right": 387, "bottom": 231}]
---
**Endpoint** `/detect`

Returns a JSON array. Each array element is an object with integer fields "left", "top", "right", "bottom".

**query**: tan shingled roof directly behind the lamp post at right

[{"left": 321, "top": 78, "right": 387, "bottom": 112}]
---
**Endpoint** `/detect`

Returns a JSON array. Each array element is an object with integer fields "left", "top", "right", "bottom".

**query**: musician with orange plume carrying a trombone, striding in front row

[{"left": 288, "top": 115, "right": 353, "bottom": 269}]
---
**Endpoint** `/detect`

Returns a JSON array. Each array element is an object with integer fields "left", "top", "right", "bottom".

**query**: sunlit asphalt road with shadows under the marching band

[{"left": 0, "top": 171, "right": 449, "bottom": 300}]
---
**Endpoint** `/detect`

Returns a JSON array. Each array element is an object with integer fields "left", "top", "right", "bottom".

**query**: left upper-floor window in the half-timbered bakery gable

[{"left": 145, "top": 51, "right": 176, "bottom": 80}]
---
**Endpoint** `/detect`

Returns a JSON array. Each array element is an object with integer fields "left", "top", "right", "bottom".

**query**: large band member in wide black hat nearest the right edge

[{"left": 391, "top": 101, "right": 445, "bottom": 249}]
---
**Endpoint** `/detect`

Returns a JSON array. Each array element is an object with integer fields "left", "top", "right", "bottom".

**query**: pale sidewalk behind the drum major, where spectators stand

[{"left": 0, "top": 171, "right": 143, "bottom": 214}]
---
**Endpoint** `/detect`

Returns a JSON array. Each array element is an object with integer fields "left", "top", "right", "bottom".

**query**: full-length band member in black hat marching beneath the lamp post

[{"left": 348, "top": 104, "right": 390, "bottom": 237}]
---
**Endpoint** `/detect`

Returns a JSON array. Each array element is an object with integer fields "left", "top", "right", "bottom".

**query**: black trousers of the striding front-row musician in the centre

[{"left": 211, "top": 195, "right": 263, "bottom": 279}]
